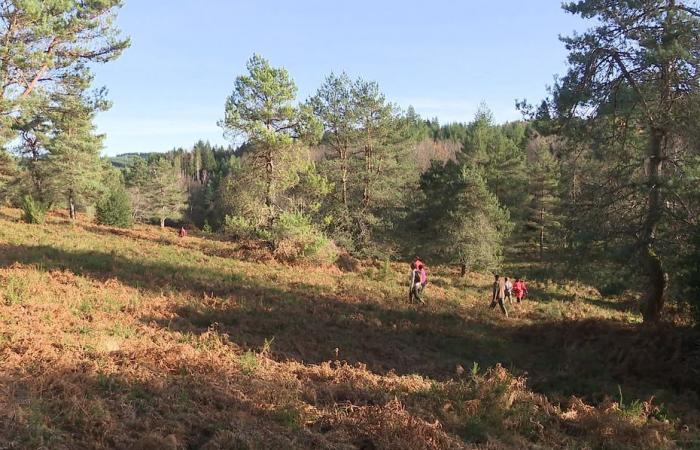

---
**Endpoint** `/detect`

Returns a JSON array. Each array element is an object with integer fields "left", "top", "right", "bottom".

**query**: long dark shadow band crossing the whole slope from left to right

[{"left": 0, "top": 245, "right": 700, "bottom": 410}]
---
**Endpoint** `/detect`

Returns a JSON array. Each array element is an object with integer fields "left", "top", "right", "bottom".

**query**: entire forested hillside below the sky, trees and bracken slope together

[{"left": 0, "top": 0, "right": 700, "bottom": 449}]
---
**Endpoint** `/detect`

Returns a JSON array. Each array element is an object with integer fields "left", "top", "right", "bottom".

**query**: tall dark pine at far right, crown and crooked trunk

[{"left": 554, "top": 0, "right": 700, "bottom": 321}]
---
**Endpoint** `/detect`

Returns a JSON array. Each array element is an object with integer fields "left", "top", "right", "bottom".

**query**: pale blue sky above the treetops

[{"left": 95, "top": 0, "right": 584, "bottom": 155}]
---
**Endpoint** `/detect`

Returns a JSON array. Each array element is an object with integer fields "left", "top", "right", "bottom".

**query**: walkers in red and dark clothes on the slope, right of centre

[{"left": 408, "top": 256, "right": 527, "bottom": 317}]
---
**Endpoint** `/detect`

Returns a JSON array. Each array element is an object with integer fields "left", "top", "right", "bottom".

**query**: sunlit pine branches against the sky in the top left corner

[{"left": 0, "top": 0, "right": 129, "bottom": 147}]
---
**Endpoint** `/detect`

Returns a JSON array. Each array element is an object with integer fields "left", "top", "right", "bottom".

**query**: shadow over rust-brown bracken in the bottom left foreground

[{"left": 0, "top": 356, "right": 370, "bottom": 450}]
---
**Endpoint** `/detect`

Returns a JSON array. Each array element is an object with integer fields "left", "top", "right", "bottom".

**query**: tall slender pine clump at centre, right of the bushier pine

[{"left": 308, "top": 74, "right": 428, "bottom": 255}]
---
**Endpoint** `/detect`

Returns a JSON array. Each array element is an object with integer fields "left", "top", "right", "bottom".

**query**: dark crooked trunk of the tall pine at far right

[{"left": 640, "top": 128, "right": 667, "bottom": 322}]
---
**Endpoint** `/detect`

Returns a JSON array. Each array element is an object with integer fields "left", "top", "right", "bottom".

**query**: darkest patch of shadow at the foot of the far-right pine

[{"left": 507, "top": 319, "right": 700, "bottom": 402}]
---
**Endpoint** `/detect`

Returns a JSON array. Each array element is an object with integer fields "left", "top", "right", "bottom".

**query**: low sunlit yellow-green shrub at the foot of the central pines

[{"left": 270, "top": 212, "right": 338, "bottom": 264}]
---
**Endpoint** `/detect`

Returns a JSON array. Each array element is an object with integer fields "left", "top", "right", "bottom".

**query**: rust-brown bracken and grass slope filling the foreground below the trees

[{"left": 0, "top": 210, "right": 700, "bottom": 449}]
